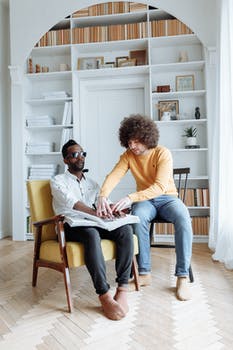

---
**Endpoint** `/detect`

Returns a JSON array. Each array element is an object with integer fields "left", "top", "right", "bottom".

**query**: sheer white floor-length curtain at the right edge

[{"left": 209, "top": 0, "right": 233, "bottom": 269}]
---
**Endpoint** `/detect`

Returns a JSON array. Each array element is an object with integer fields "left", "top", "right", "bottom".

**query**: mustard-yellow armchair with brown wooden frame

[{"left": 27, "top": 180, "right": 139, "bottom": 312}]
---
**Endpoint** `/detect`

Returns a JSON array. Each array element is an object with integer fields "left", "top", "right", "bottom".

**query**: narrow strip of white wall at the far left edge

[{"left": 0, "top": 1, "right": 11, "bottom": 238}]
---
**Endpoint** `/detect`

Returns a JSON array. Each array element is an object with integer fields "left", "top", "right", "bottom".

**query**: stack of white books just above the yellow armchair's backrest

[{"left": 28, "top": 164, "right": 58, "bottom": 180}]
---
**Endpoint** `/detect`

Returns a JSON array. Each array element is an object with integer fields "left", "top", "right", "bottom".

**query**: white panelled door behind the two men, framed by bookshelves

[{"left": 80, "top": 76, "right": 145, "bottom": 201}]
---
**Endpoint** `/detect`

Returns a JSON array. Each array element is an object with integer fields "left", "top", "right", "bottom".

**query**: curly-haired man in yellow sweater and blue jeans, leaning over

[{"left": 97, "top": 114, "right": 193, "bottom": 300}]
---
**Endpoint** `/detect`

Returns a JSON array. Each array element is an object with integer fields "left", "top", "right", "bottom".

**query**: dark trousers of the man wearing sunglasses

[{"left": 65, "top": 223, "right": 134, "bottom": 295}]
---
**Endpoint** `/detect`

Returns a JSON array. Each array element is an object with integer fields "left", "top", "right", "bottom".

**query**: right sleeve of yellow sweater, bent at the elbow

[{"left": 129, "top": 148, "right": 177, "bottom": 202}]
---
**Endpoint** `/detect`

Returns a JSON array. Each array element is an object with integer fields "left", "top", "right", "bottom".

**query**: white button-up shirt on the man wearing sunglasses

[{"left": 50, "top": 170, "right": 100, "bottom": 215}]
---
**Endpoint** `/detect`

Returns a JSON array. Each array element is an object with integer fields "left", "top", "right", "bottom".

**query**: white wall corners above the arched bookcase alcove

[{"left": 10, "top": 0, "right": 216, "bottom": 65}]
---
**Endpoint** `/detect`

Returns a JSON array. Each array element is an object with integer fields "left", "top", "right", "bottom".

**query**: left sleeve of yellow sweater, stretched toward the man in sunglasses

[{"left": 100, "top": 152, "right": 129, "bottom": 197}]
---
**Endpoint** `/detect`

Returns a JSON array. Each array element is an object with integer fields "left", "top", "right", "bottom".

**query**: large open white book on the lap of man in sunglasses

[{"left": 65, "top": 210, "right": 140, "bottom": 231}]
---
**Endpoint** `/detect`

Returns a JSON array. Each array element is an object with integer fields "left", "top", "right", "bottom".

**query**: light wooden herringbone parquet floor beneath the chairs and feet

[{"left": 0, "top": 239, "right": 233, "bottom": 350}]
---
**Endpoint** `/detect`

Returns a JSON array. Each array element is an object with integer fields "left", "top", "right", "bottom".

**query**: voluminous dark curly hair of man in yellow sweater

[{"left": 119, "top": 114, "right": 159, "bottom": 149}]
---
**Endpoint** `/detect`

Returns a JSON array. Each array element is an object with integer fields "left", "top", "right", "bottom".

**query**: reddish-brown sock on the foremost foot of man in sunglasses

[{"left": 99, "top": 291, "right": 125, "bottom": 321}]
